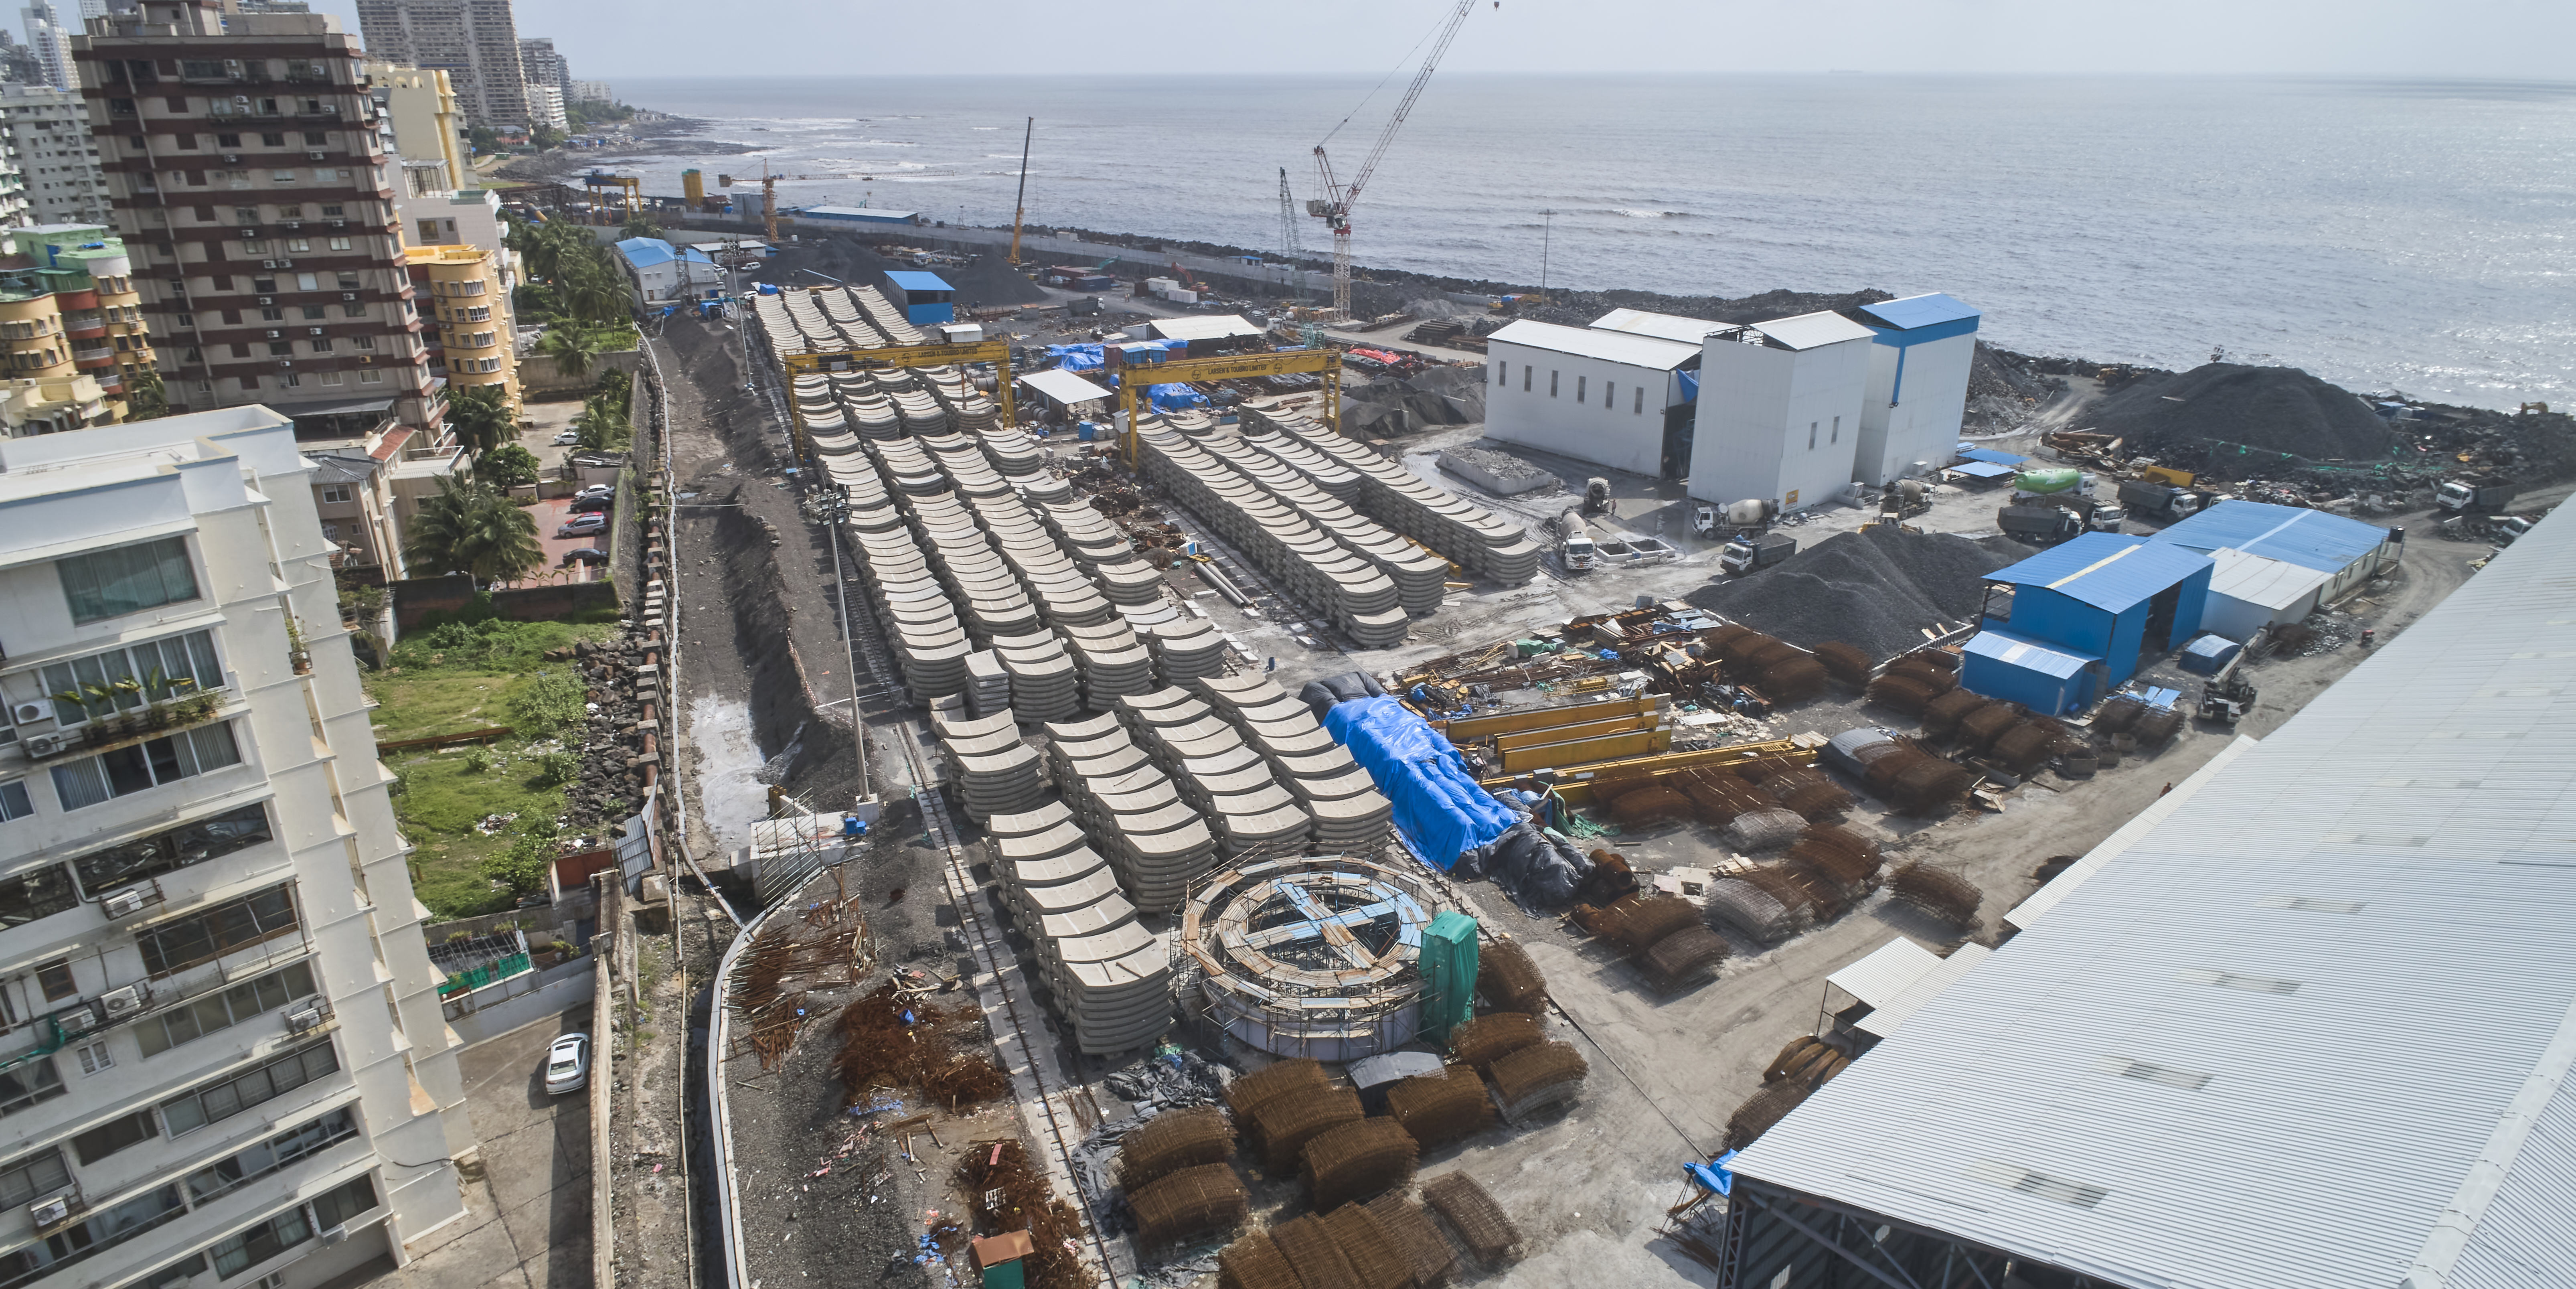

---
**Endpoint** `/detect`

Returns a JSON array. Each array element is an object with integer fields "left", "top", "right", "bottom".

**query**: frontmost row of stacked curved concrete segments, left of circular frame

[{"left": 984, "top": 802, "right": 1172, "bottom": 1054}]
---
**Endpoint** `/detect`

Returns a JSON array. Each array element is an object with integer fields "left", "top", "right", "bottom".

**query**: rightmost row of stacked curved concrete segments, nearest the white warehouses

[{"left": 1241, "top": 399, "right": 1541, "bottom": 585}]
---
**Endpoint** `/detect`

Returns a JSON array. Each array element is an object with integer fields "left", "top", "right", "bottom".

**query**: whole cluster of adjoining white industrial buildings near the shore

[{"left": 1486, "top": 294, "right": 1979, "bottom": 511}]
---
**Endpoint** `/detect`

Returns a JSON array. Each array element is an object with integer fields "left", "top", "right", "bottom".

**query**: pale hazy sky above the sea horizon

[{"left": 296, "top": 0, "right": 2576, "bottom": 83}]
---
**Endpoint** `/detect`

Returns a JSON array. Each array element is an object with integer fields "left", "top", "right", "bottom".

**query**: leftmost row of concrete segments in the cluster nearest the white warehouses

[{"left": 1138, "top": 418, "right": 1412, "bottom": 650}]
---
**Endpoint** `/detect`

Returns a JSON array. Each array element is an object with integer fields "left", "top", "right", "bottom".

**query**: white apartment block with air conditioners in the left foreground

[{"left": 0, "top": 407, "right": 474, "bottom": 1289}]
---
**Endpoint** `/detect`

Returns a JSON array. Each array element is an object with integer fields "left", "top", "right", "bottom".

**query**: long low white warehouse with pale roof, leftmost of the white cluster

[{"left": 1484, "top": 320, "right": 1700, "bottom": 477}]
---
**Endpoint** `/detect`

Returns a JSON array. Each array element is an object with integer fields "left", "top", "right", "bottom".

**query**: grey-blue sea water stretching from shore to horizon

[{"left": 618, "top": 75, "right": 2576, "bottom": 407}]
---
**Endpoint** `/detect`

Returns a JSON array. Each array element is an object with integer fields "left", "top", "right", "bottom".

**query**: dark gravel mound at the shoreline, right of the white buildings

[{"left": 2086, "top": 363, "right": 2398, "bottom": 477}]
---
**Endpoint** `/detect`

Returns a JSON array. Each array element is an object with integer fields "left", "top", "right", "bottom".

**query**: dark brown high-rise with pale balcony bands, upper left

[{"left": 80, "top": 0, "right": 454, "bottom": 454}]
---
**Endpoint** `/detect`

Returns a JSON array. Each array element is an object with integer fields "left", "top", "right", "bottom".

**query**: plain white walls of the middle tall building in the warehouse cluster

[{"left": 1690, "top": 332, "right": 1873, "bottom": 511}]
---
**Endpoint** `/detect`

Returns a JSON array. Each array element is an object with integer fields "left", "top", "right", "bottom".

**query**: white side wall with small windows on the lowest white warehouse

[{"left": 1484, "top": 340, "right": 1679, "bottom": 477}]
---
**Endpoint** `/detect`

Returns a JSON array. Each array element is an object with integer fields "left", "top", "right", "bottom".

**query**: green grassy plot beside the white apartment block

[{"left": 366, "top": 621, "right": 616, "bottom": 918}]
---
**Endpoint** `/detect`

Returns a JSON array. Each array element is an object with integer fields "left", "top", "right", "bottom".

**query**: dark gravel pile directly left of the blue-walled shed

[{"left": 1685, "top": 529, "right": 2037, "bottom": 657}]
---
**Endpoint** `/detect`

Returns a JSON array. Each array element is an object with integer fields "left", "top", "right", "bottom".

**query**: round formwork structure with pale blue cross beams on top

[{"left": 1180, "top": 856, "right": 1440, "bottom": 1062}]
